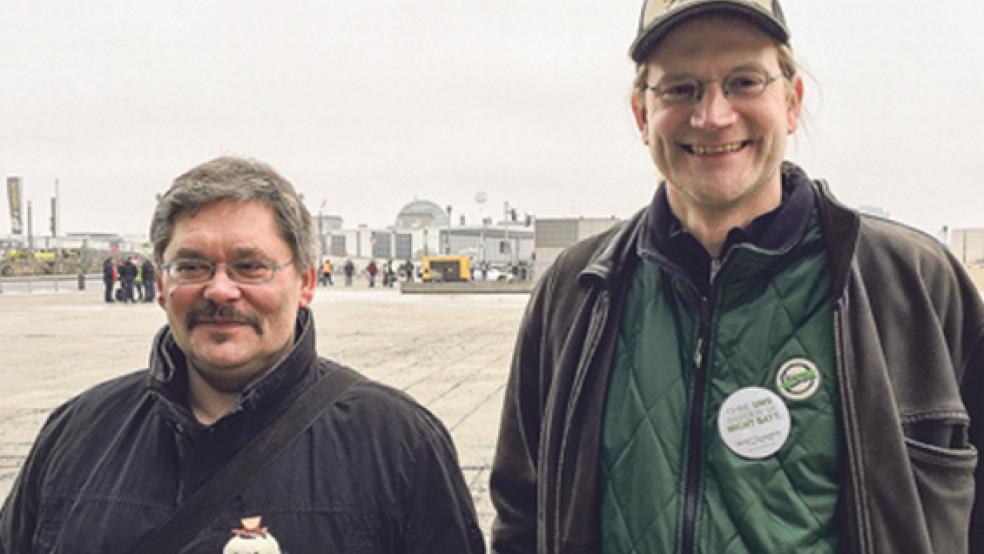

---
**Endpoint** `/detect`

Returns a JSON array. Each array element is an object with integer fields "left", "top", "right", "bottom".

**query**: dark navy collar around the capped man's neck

[{"left": 637, "top": 162, "right": 816, "bottom": 294}]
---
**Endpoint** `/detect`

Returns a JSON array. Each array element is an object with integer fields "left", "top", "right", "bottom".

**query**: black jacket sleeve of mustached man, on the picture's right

[{"left": 403, "top": 413, "right": 485, "bottom": 554}]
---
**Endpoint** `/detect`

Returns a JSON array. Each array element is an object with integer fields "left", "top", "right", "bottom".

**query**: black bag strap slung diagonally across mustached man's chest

[{"left": 131, "top": 366, "right": 365, "bottom": 554}]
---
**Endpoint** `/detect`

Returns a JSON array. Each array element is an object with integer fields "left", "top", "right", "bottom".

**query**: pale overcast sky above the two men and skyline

[{"left": 0, "top": 0, "right": 984, "bottom": 235}]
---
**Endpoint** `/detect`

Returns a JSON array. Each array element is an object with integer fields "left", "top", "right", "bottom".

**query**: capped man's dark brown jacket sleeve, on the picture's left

[{"left": 489, "top": 272, "right": 556, "bottom": 554}]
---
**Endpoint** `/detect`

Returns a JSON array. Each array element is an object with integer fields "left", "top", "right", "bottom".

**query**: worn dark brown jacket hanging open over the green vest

[{"left": 491, "top": 178, "right": 984, "bottom": 554}]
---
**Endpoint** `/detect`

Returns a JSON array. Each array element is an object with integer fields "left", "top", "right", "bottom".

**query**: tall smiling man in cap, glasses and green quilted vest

[{"left": 491, "top": 0, "right": 984, "bottom": 554}]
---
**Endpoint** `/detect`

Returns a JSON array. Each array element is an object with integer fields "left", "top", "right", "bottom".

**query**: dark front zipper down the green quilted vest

[{"left": 680, "top": 294, "right": 714, "bottom": 554}]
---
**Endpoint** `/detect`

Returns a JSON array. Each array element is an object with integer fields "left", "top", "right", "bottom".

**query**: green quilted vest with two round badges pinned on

[{"left": 600, "top": 218, "right": 842, "bottom": 554}]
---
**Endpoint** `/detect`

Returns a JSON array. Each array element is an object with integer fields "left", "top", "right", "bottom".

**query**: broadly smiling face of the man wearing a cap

[{"left": 633, "top": 16, "right": 803, "bottom": 221}]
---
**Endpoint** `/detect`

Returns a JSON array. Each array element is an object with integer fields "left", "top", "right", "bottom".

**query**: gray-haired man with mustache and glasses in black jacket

[{"left": 0, "top": 157, "right": 484, "bottom": 554}]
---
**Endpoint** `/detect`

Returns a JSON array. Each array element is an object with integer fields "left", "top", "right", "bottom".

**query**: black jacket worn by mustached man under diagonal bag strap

[{"left": 0, "top": 310, "right": 484, "bottom": 554}]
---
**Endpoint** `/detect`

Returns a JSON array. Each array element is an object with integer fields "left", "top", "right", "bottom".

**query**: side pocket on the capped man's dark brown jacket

[{"left": 905, "top": 422, "right": 978, "bottom": 554}]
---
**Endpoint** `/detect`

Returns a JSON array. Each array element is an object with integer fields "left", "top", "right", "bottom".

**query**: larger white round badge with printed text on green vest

[{"left": 718, "top": 387, "right": 790, "bottom": 460}]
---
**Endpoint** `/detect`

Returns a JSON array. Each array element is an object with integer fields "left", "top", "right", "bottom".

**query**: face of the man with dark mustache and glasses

[{"left": 157, "top": 200, "right": 316, "bottom": 393}]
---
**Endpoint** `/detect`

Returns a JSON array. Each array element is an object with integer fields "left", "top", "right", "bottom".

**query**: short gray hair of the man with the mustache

[{"left": 150, "top": 156, "right": 320, "bottom": 271}]
